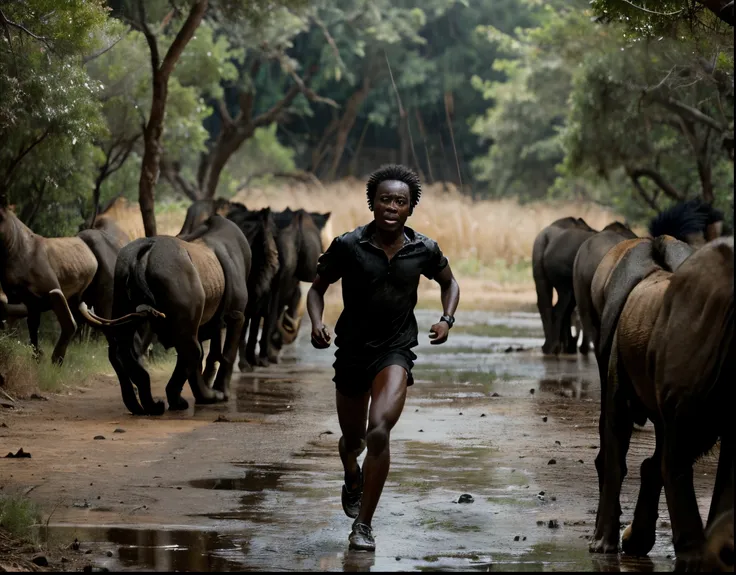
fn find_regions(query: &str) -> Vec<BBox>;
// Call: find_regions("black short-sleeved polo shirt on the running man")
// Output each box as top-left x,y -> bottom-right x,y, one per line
317,222 -> 448,356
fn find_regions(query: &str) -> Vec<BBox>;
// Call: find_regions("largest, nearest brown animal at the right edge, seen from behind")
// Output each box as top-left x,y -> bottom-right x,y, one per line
591,236 -> 736,568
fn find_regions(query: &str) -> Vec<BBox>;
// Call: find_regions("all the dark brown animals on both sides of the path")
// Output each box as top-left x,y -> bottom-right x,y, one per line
0,195 -> 735,570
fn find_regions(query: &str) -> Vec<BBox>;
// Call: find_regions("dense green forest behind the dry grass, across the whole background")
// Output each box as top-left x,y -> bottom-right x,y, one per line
0,0 -> 734,235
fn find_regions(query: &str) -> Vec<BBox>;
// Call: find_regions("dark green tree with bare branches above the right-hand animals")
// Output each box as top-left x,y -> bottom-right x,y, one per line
564,10 -> 734,210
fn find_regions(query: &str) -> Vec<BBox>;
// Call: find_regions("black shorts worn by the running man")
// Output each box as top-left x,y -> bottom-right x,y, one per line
332,349 -> 417,397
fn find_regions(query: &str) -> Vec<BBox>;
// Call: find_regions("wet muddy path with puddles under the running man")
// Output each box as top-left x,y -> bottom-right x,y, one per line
0,311 -> 715,571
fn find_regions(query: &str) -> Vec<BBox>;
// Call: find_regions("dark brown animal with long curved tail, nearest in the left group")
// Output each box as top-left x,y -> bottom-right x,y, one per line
82,215 -> 251,415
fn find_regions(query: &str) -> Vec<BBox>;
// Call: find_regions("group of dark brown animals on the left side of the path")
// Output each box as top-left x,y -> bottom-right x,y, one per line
0,199 -> 330,415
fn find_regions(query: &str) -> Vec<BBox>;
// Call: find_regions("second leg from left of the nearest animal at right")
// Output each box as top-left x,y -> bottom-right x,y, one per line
621,421 -> 662,557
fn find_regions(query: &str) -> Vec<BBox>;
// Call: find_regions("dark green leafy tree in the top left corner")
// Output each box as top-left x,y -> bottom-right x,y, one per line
0,0 -> 105,233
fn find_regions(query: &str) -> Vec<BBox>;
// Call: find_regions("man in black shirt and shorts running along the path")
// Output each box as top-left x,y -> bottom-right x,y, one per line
307,165 -> 460,551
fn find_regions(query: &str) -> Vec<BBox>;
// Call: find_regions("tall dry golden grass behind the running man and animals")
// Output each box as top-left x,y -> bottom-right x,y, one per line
98,179 -> 628,300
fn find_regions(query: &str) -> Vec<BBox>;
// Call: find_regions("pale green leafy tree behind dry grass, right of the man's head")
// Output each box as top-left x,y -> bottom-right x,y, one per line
473,4 -> 601,199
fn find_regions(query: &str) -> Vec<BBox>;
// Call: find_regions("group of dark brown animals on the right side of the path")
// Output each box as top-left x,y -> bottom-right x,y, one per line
533,201 -> 736,571
